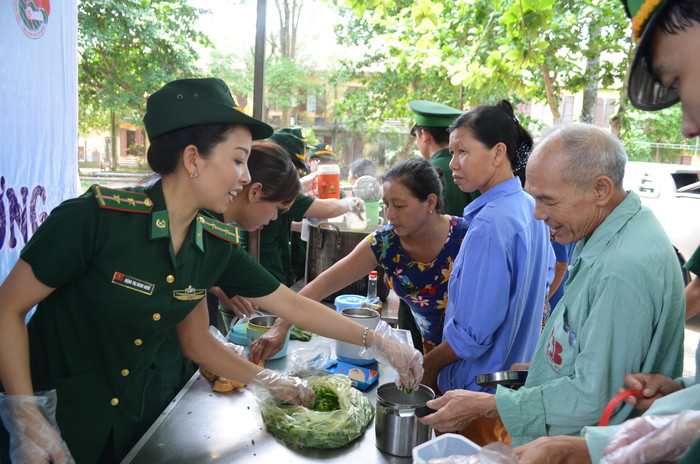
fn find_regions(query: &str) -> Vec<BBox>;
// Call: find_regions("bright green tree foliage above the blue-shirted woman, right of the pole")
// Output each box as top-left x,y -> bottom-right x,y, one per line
336,0 -> 629,129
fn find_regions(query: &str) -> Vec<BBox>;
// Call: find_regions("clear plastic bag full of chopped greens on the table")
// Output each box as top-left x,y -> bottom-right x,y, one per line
257,374 -> 374,449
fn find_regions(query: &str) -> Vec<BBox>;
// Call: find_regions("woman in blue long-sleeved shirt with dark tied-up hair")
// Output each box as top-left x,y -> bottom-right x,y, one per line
423,100 -> 554,444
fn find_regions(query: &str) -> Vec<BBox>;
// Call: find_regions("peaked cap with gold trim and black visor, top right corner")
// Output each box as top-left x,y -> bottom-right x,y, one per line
622,0 -> 680,111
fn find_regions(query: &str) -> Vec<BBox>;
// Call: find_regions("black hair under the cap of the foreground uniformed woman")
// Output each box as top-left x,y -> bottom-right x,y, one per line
146,124 -> 241,176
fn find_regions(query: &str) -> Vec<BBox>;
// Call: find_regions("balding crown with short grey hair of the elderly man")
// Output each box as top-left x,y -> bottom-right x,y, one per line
528,123 -> 627,190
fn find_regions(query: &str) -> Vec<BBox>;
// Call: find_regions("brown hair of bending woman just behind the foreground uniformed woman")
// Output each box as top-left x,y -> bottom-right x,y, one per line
248,140 -> 301,203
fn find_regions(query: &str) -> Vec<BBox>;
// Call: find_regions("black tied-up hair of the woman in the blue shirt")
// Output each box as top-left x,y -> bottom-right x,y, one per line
447,100 -> 532,185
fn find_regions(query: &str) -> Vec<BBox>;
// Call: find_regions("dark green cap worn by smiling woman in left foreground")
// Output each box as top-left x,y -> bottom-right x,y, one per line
143,77 -> 272,140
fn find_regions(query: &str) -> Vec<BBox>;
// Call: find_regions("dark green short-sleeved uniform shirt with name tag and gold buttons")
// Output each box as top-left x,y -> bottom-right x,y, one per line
8,181 -> 279,463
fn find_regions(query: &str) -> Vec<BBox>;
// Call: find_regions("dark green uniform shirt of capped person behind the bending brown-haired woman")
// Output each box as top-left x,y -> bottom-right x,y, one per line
241,194 -> 315,287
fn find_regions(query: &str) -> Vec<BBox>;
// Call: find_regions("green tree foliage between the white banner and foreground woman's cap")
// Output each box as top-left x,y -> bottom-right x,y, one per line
78,0 -> 210,130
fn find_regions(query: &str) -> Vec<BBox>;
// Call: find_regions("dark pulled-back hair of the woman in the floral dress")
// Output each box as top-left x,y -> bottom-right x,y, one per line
382,158 -> 443,212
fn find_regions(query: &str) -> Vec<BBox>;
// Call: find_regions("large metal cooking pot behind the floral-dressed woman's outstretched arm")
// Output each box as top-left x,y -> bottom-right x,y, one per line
305,222 -> 389,302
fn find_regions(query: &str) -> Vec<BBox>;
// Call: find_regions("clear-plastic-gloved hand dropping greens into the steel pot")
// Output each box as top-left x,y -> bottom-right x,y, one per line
360,321 -> 423,391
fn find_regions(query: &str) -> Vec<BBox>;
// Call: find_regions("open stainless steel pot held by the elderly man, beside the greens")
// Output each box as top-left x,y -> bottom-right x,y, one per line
374,382 -> 435,456
